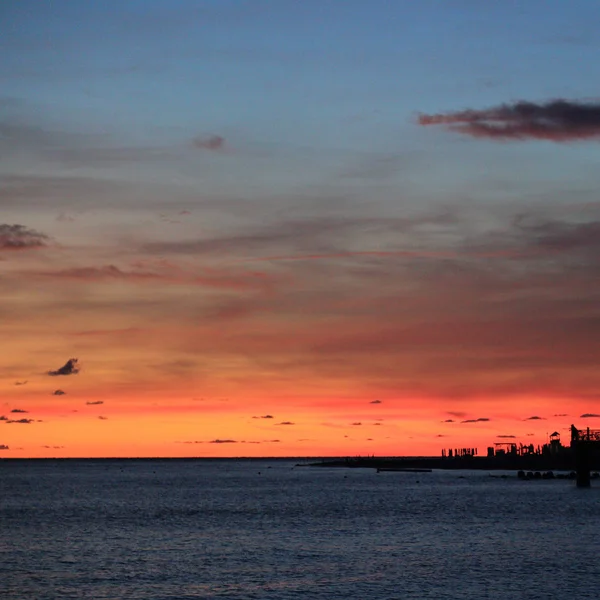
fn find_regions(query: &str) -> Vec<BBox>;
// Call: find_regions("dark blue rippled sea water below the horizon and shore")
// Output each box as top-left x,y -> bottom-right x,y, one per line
0,460 -> 600,600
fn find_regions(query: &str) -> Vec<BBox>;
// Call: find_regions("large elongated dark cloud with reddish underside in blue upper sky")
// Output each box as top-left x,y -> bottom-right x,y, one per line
419,99 -> 600,142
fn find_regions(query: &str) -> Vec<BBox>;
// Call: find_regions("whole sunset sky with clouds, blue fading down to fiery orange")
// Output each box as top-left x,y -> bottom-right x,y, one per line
0,0 -> 600,458
